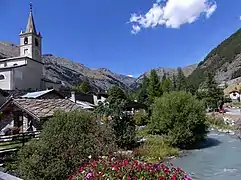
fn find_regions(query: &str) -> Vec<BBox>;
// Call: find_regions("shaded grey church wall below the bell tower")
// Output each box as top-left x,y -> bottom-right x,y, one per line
14,59 -> 43,90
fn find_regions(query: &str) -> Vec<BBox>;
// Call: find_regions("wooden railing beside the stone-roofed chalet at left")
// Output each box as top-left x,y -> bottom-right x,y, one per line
0,131 -> 40,154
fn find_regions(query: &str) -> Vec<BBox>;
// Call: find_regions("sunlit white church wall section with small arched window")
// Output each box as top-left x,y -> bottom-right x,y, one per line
0,69 -> 12,90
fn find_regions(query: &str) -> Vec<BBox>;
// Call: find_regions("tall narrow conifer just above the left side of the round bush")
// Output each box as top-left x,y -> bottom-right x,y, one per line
148,69 -> 162,102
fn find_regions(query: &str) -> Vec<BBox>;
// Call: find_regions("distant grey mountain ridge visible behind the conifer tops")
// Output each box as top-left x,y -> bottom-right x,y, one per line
132,64 -> 197,87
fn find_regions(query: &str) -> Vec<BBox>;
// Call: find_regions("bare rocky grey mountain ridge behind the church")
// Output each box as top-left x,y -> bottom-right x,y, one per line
0,42 -> 135,91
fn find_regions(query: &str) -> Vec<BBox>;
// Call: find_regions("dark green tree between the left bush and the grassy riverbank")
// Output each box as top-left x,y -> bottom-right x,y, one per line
96,86 -> 135,149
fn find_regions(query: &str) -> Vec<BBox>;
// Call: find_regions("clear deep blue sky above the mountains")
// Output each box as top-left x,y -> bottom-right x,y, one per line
0,0 -> 241,76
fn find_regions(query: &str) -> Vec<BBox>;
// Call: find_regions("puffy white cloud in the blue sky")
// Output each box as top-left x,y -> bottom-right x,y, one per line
129,0 -> 217,34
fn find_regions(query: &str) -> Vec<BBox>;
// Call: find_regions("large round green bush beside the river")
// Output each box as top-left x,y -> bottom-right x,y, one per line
149,91 -> 207,148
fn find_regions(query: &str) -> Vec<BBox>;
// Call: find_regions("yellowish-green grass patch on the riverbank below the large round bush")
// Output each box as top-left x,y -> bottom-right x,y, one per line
134,128 -> 181,163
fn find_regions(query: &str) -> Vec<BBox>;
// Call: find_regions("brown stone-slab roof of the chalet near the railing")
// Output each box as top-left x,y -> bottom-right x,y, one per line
1,99 -> 82,119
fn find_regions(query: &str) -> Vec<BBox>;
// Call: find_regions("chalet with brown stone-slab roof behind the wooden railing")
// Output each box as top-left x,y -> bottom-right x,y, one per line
0,98 -> 82,134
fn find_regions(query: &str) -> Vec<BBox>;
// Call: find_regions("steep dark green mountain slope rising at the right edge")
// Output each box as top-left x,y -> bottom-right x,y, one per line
189,28 -> 241,86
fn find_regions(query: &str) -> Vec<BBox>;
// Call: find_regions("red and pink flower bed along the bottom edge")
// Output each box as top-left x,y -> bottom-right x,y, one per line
68,157 -> 191,180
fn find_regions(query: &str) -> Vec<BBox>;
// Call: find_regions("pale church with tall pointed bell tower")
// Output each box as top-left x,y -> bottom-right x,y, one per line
0,5 -> 55,90
